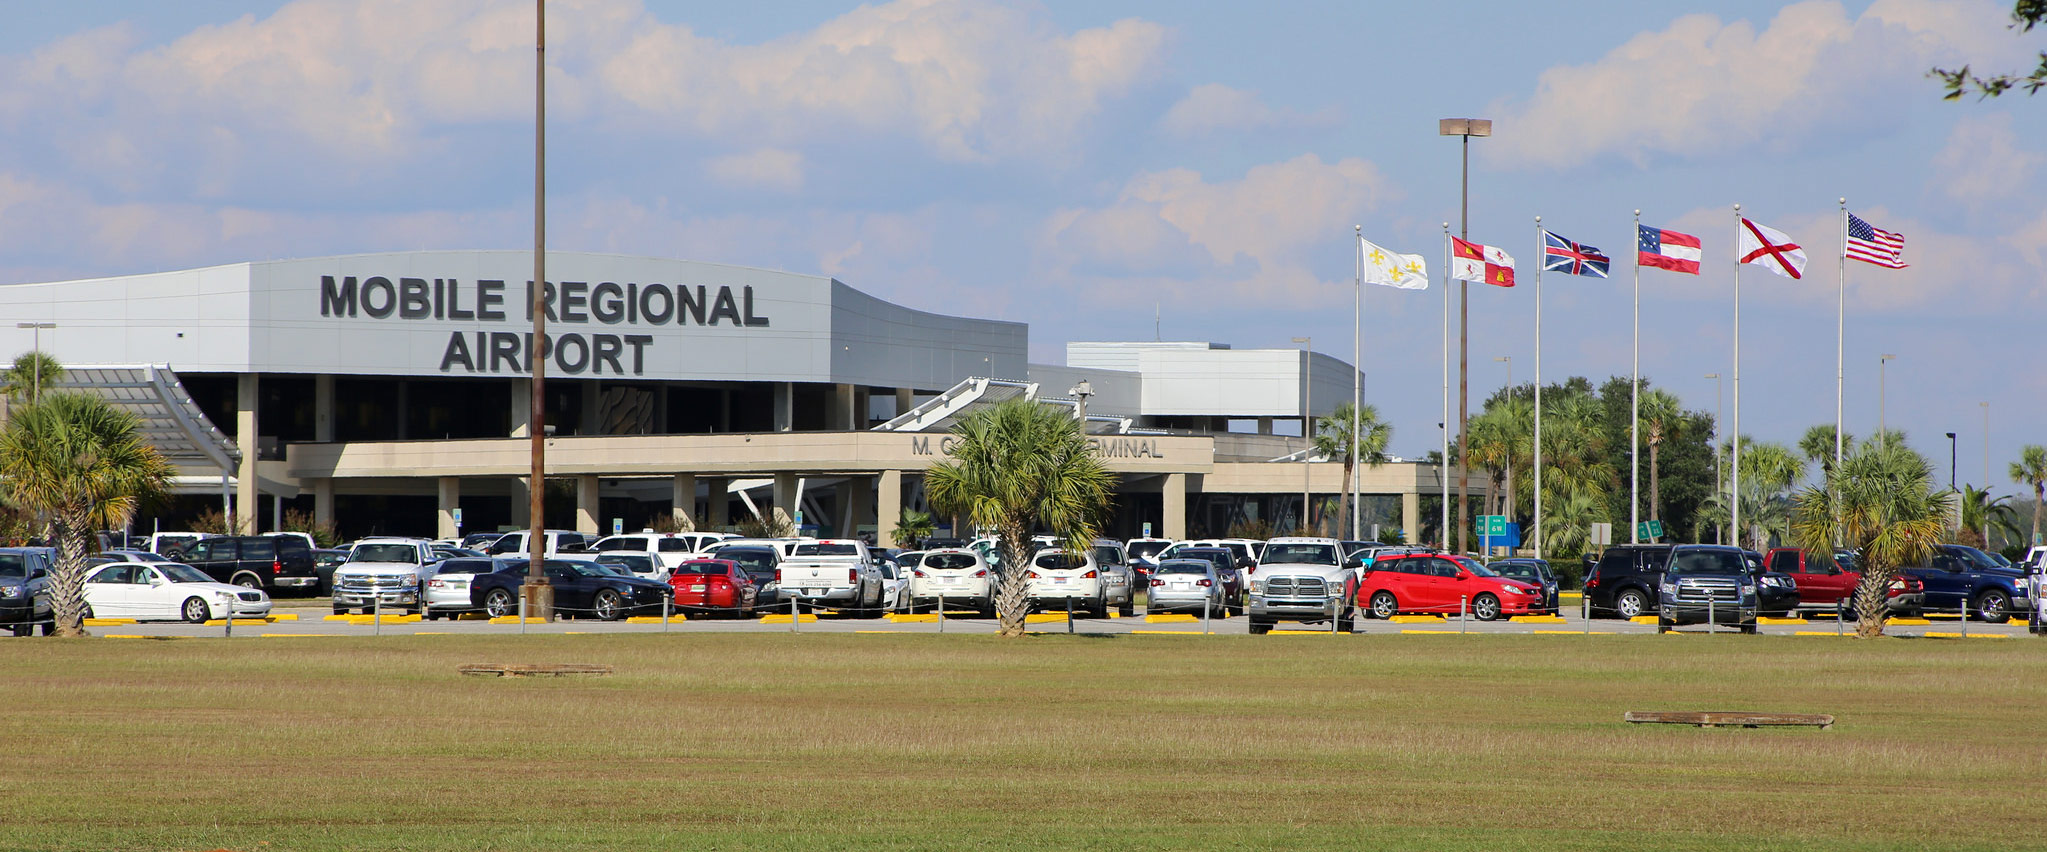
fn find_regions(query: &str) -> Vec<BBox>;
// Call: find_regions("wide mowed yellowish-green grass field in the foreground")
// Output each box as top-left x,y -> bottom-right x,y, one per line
0,635 -> 2047,850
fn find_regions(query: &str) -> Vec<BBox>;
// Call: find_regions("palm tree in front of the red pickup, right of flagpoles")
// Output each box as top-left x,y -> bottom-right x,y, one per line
1791,440 -> 1955,637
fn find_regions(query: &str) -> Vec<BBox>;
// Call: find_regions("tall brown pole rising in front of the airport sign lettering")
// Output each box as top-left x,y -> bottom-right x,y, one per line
520,0 -> 555,621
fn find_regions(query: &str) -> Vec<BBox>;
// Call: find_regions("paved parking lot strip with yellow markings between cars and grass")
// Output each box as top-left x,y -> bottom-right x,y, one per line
68,598 -> 2029,641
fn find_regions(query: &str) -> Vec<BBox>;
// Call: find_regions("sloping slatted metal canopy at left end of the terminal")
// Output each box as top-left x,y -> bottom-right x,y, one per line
49,365 -> 242,475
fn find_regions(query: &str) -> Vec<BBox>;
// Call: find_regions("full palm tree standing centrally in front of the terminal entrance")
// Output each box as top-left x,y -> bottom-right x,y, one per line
923,397 -> 1116,637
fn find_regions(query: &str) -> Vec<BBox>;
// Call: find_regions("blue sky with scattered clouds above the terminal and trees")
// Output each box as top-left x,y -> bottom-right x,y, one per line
0,0 -> 2047,492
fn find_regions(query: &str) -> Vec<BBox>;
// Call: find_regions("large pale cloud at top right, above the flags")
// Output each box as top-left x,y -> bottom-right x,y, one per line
1486,0 -> 2024,166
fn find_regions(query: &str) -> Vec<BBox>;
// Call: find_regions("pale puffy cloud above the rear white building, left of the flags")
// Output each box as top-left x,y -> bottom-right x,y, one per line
1042,154 -> 1398,303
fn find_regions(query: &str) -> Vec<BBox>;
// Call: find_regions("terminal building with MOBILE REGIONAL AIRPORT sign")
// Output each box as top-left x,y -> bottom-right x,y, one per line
0,250 -> 1443,541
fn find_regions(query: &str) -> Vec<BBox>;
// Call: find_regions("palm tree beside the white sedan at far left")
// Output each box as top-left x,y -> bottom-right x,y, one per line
0,393 -> 172,637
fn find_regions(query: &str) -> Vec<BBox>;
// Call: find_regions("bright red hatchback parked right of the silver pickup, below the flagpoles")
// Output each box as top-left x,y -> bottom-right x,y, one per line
1357,553 -> 1541,621
